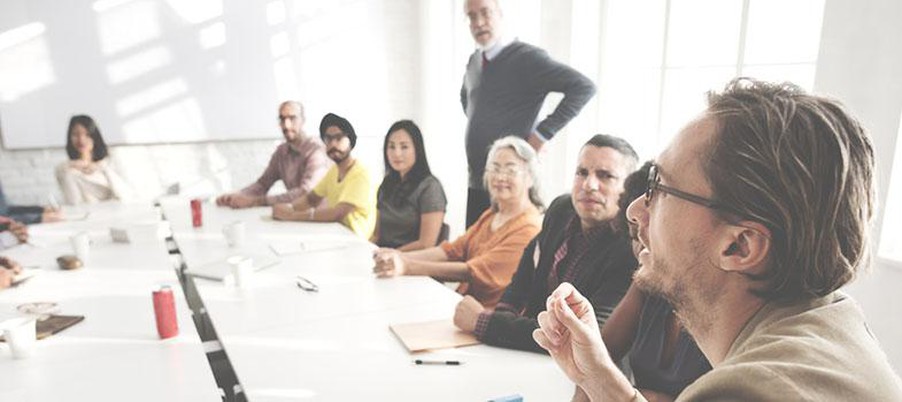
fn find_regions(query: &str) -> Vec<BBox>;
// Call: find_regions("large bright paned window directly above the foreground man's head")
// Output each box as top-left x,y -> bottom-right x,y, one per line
588,0 -> 824,162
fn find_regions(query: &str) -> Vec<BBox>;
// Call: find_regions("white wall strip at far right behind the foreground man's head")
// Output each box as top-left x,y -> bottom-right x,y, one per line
814,0 -> 902,373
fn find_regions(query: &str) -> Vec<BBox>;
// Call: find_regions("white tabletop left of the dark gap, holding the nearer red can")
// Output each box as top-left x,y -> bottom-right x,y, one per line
0,202 -> 221,401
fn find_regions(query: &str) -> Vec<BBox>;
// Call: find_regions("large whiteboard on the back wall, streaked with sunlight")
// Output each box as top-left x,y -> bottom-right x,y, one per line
0,0 -> 406,149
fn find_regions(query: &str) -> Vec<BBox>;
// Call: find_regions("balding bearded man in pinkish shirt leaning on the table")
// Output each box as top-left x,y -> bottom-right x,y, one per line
216,101 -> 331,208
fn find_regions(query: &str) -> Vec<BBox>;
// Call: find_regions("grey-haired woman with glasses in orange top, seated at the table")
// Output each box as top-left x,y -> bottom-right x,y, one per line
373,136 -> 542,307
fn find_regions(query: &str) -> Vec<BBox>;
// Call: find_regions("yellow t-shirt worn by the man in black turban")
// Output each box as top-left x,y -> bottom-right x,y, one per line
313,161 -> 376,239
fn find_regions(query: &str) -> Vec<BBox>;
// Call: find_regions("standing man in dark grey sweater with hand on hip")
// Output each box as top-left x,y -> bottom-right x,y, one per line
460,0 -> 595,227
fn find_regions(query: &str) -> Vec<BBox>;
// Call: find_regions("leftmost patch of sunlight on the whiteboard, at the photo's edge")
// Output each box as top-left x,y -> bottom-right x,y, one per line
0,22 -> 56,102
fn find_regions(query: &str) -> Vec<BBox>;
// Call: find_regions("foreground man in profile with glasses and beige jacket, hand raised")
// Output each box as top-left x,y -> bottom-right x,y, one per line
533,79 -> 902,401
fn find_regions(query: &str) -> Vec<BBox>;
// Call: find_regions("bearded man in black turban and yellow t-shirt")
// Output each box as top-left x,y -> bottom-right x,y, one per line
272,113 -> 376,239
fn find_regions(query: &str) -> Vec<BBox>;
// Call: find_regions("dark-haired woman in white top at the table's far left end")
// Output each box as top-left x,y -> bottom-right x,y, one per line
56,115 -> 131,205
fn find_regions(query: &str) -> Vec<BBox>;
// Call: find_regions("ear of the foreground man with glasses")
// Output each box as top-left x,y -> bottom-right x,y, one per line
718,221 -> 771,275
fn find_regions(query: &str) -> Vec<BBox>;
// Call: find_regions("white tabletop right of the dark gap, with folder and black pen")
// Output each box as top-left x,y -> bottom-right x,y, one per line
161,198 -> 573,402
